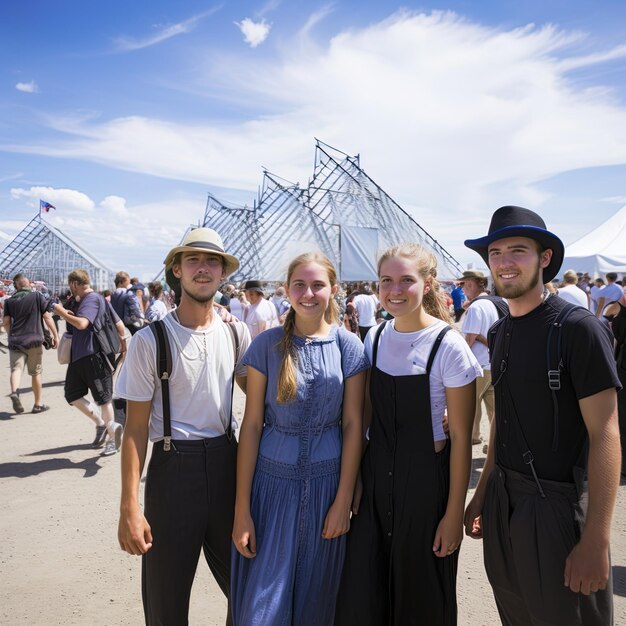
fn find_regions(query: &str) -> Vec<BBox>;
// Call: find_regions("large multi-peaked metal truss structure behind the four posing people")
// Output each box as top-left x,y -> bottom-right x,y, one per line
203,140 -> 462,281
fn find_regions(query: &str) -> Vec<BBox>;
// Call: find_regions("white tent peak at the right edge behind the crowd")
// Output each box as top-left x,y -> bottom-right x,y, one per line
561,206 -> 626,277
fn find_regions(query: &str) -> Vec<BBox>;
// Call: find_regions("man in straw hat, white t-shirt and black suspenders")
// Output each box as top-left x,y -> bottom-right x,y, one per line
116,228 -> 250,624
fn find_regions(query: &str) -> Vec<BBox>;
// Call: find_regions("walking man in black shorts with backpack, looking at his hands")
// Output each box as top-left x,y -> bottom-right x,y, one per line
53,269 -> 126,456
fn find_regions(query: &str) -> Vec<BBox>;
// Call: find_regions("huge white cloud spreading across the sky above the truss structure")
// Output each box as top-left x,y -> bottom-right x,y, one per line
0,7 -> 626,268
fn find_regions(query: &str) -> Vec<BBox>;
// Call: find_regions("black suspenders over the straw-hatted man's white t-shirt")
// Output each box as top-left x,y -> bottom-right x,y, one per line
150,320 -> 239,452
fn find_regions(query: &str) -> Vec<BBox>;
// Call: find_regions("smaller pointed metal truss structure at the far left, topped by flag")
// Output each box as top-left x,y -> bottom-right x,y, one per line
0,214 -> 114,293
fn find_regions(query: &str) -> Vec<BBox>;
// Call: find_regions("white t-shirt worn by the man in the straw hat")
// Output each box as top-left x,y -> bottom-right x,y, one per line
115,313 -> 250,441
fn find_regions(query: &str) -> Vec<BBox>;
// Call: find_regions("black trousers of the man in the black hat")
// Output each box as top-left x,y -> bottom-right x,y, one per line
482,465 -> 613,626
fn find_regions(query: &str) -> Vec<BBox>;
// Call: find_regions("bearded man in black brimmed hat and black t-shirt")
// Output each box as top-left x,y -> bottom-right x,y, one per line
465,206 -> 620,626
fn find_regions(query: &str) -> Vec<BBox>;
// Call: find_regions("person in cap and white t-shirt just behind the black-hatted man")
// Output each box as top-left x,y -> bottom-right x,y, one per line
458,270 -> 499,452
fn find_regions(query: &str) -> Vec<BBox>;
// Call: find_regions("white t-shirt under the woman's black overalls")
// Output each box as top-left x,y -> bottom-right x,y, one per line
365,320 -> 483,441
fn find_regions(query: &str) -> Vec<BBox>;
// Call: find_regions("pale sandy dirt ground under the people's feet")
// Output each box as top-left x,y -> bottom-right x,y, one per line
0,335 -> 626,626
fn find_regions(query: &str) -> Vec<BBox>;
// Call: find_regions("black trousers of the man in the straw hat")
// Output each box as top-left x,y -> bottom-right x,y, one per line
142,435 -> 237,626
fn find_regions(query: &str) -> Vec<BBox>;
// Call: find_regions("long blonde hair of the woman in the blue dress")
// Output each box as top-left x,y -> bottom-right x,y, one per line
276,252 -> 339,404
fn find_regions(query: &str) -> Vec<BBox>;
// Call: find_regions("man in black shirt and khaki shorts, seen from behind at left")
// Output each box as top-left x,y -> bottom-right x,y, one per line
2,274 -> 59,413
